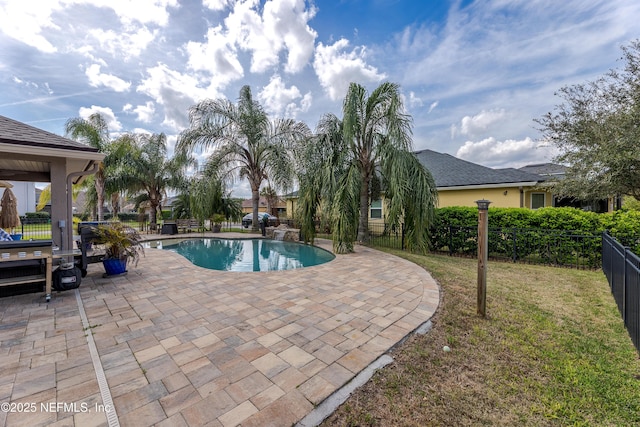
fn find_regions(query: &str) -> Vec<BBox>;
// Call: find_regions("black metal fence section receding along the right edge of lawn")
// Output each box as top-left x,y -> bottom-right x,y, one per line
602,232 -> 640,351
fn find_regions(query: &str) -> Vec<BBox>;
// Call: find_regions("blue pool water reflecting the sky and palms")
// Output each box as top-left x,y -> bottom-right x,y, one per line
158,238 -> 335,271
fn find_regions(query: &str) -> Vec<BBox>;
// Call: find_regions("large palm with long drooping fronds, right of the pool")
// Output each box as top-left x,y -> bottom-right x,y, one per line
299,82 -> 437,253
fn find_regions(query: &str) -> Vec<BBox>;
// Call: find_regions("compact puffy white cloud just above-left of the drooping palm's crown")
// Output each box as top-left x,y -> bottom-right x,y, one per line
313,39 -> 386,101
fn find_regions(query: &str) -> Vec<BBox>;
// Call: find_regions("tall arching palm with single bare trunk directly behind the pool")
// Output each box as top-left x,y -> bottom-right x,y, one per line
178,86 -> 309,231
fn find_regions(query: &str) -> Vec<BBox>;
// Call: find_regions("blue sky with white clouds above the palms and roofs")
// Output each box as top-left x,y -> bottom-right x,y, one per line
0,0 -> 640,197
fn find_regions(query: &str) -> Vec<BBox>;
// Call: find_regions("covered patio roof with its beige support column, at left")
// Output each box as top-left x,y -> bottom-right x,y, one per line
0,116 -> 104,249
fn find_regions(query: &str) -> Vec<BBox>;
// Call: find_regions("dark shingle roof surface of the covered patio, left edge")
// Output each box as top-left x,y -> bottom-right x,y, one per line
0,116 -> 98,152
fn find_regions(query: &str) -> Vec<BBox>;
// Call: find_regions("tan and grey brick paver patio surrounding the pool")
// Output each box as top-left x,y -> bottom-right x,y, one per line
0,234 -> 439,427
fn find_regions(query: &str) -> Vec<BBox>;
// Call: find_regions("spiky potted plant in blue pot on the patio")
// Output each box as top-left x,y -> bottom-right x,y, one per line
95,222 -> 144,276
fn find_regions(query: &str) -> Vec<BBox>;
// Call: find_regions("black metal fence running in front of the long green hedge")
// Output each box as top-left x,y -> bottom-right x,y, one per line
369,223 -> 602,269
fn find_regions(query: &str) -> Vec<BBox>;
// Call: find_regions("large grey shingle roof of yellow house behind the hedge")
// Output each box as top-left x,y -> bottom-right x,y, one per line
415,150 -> 545,188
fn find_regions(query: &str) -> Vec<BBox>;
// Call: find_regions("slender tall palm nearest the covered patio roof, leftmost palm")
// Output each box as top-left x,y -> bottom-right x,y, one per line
64,113 -> 110,221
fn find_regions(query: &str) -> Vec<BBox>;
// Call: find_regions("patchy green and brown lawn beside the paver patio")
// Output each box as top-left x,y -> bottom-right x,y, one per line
323,250 -> 640,426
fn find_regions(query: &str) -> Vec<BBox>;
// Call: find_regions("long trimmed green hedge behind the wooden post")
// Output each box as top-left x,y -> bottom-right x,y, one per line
431,207 -> 640,265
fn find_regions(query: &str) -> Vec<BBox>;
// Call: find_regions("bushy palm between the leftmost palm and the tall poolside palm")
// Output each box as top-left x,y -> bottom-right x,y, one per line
107,133 -> 191,224
